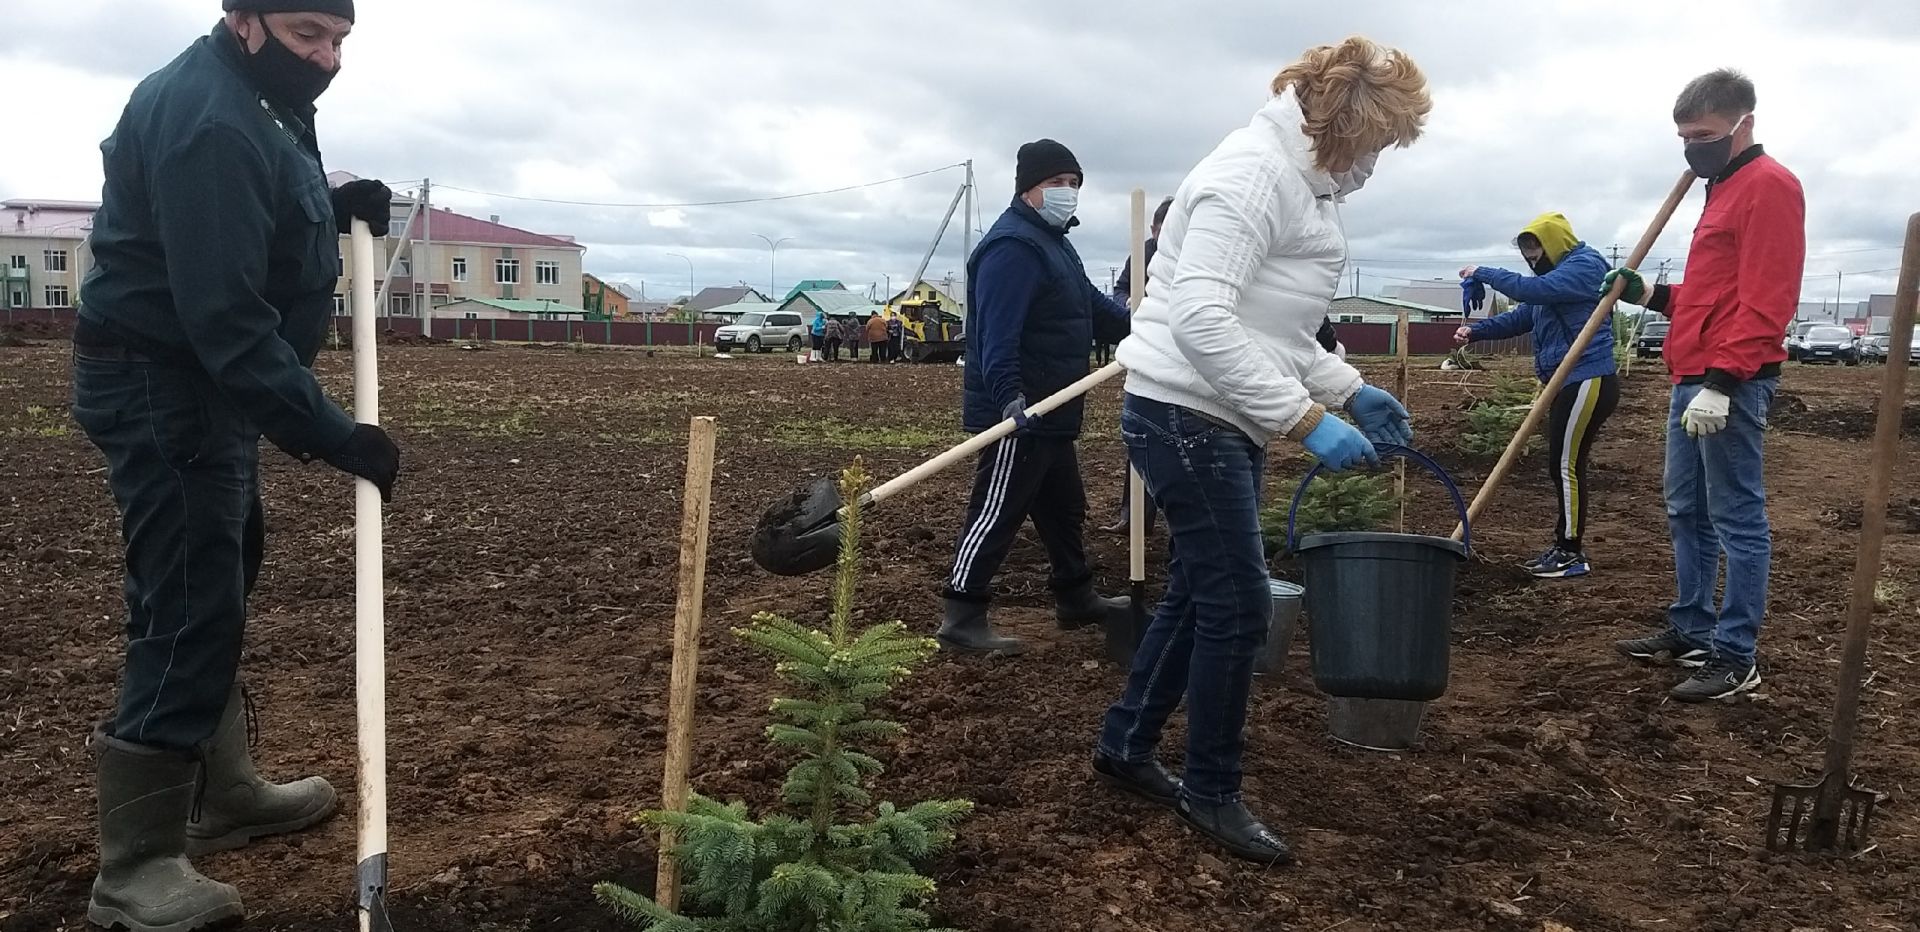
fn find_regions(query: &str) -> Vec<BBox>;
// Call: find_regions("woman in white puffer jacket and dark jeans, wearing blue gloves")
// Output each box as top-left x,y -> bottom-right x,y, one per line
1092,37 -> 1432,863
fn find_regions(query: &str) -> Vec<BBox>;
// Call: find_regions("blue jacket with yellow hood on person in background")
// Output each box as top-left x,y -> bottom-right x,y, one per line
1471,213 -> 1615,382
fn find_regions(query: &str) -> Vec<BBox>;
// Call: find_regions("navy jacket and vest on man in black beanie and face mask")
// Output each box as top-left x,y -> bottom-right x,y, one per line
964,198 -> 1129,436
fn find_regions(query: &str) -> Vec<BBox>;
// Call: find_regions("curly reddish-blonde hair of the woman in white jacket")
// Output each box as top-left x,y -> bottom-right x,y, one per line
1273,37 -> 1434,171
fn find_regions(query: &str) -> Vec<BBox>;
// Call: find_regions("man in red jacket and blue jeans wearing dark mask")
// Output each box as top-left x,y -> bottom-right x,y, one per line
1601,69 -> 1807,701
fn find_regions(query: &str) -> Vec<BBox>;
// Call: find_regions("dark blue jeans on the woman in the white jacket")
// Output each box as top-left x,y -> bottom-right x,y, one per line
1100,394 -> 1273,803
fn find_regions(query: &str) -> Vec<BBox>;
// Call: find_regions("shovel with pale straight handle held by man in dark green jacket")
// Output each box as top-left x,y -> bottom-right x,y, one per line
349,219 -> 394,932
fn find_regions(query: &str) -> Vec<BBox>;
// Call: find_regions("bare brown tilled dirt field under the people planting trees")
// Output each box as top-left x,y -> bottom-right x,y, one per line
0,344 -> 1920,932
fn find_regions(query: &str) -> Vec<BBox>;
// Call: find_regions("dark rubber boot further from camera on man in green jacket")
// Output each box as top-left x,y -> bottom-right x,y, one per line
186,684 -> 336,855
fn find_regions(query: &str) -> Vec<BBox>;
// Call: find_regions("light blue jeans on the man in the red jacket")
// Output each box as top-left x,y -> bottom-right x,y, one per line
1667,379 -> 1780,663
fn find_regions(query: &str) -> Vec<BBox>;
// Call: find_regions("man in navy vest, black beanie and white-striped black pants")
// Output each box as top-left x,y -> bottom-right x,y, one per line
939,138 -> 1129,653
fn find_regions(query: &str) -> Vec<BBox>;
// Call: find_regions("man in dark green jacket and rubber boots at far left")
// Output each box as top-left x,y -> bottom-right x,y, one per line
73,0 -> 399,932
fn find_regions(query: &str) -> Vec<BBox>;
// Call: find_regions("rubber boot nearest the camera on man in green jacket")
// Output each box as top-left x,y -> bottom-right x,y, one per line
86,734 -> 246,932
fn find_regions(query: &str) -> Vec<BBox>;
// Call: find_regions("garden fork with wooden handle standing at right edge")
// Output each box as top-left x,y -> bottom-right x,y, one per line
1766,213 -> 1920,851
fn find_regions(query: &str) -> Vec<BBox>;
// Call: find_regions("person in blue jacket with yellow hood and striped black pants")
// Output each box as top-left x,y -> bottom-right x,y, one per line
1453,213 -> 1620,578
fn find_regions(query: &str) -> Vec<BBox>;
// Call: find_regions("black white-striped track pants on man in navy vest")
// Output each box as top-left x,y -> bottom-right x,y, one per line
943,436 -> 1092,601
